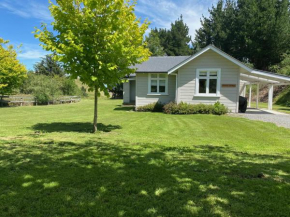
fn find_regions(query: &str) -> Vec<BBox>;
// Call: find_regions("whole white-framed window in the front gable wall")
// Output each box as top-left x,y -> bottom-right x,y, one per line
196,69 -> 221,96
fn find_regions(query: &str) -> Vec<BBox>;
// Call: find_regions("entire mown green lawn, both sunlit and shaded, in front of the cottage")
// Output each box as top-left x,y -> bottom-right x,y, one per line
0,99 -> 290,217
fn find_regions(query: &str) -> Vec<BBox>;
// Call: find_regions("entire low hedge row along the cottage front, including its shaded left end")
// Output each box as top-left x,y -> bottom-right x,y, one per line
137,102 -> 229,115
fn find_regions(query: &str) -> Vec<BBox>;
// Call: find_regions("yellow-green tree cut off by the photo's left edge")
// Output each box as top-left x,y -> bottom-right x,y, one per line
0,38 -> 27,95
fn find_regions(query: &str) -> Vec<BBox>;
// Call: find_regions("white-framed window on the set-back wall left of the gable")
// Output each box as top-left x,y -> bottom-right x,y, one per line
148,74 -> 168,94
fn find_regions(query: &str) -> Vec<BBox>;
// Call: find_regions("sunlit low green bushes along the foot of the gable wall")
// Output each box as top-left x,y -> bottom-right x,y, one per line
163,102 -> 228,115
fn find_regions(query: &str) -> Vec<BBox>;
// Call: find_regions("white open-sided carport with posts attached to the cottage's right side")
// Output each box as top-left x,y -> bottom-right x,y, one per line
240,68 -> 290,110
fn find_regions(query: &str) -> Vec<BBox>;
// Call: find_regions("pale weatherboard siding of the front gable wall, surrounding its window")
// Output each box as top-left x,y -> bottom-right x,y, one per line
176,50 -> 240,112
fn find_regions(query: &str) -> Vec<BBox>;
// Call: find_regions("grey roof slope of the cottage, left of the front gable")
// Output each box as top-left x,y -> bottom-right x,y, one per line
132,56 -> 190,73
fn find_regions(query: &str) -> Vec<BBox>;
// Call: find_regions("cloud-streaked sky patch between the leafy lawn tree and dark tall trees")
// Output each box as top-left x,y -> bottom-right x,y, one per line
135,0 -> 217,39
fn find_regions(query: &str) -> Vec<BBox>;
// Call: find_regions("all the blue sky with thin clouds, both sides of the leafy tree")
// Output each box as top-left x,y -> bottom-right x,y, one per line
0,0 -> 217,69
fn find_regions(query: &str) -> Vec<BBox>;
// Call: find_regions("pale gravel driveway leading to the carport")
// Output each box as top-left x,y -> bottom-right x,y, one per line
230,109 -> 290,129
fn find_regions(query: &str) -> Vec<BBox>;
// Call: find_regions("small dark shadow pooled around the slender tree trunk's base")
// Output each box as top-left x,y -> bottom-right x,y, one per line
32,122 -> 121,133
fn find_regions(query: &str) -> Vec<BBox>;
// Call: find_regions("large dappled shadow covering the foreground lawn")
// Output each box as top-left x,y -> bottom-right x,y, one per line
0,141 -> 290,217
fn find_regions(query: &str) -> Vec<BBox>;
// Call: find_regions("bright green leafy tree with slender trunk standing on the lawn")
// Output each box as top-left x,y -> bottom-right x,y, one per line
35,0 -> 150,132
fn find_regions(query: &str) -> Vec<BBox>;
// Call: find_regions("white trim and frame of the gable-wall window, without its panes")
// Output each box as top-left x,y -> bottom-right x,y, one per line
195,68 -> 221,97
